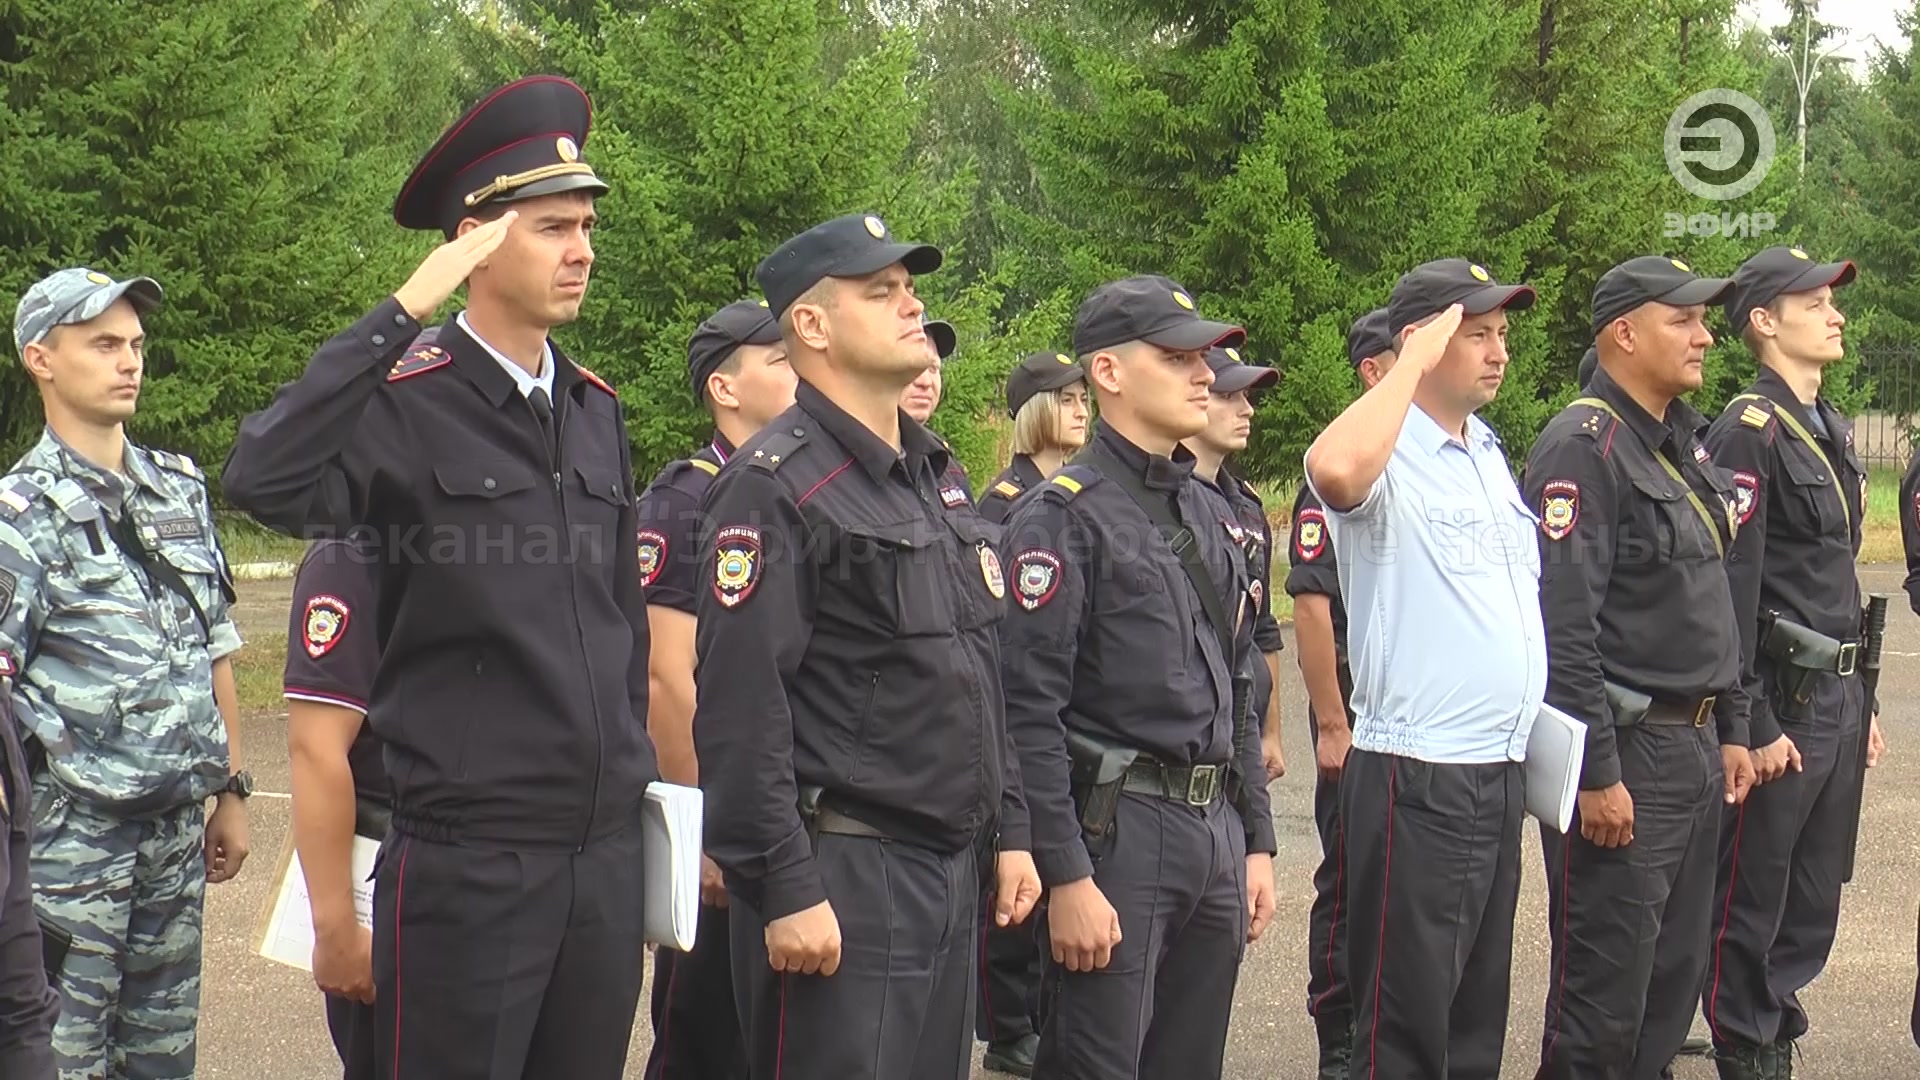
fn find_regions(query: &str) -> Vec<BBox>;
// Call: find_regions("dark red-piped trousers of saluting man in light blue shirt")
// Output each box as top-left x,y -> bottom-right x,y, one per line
1340,748 -> 1526,1080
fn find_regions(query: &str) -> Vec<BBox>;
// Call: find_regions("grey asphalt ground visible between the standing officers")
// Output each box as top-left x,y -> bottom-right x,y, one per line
200,565 -> 1920,1080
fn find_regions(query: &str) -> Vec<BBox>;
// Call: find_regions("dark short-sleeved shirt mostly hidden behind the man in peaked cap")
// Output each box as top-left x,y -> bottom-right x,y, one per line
280,540 -> 392,814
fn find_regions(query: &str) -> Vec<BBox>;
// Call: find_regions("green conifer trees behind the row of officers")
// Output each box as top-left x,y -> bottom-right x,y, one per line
0,0 -> 1920,484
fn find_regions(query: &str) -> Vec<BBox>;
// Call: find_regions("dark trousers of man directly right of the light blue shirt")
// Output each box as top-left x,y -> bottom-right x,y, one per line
1536,705 -> 1726,1080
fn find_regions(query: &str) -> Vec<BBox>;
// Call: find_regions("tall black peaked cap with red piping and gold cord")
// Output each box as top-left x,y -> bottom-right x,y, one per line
394,75 -> 607,233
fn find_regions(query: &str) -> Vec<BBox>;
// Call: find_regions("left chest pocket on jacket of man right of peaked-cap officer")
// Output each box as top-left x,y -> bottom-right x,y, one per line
844,521 -> 960,638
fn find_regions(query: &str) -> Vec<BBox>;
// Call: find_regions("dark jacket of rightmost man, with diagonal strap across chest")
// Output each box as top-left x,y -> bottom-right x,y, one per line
1707,367 -> 1866,746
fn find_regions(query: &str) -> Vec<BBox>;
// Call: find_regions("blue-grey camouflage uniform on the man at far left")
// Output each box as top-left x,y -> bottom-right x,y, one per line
0,430 -> 240,1080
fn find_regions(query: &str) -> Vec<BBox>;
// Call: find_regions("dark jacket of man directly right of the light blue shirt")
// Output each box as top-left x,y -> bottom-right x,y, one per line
1526,359 -> 1747,790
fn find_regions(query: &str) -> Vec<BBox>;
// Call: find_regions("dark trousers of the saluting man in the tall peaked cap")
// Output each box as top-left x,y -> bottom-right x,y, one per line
372,819 -> 645,1080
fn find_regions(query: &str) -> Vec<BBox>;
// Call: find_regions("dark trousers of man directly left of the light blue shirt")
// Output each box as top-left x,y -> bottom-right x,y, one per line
1033,792 -> 1246,1080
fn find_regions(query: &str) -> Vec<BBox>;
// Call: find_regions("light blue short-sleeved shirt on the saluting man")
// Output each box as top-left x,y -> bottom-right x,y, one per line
1315,405 -> 1548,765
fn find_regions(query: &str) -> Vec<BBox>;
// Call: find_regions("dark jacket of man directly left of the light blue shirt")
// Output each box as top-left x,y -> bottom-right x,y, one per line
1002,423 -> 1275,888
